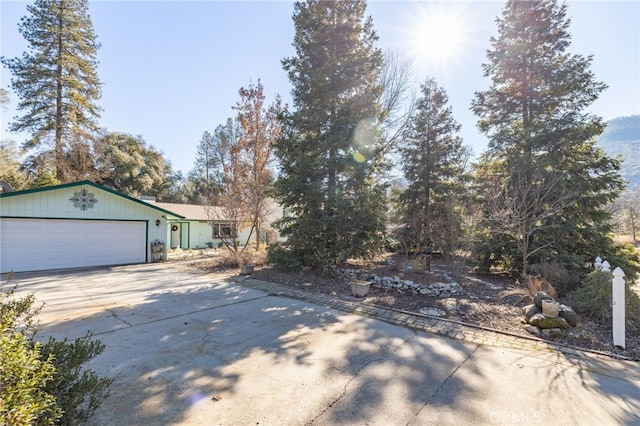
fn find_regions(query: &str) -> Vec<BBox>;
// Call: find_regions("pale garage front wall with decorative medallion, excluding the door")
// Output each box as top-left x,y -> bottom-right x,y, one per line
0,185 -> 178,262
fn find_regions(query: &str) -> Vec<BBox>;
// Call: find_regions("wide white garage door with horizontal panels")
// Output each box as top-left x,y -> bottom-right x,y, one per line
0,219 -> 146,272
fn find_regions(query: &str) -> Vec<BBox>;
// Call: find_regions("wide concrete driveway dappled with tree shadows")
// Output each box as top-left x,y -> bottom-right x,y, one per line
8,264 -> 640,425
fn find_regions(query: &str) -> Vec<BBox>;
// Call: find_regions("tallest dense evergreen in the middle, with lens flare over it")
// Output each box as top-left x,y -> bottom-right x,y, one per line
275,0 -> 385,267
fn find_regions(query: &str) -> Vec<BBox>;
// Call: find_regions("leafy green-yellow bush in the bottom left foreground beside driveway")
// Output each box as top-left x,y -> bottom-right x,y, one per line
0,277 -> 112,425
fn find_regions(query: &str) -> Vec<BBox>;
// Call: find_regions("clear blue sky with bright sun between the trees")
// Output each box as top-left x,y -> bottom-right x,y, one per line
0,0 -> 640,174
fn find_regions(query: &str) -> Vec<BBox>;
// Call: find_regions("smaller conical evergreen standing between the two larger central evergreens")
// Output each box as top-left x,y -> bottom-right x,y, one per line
400,79 -> 469,252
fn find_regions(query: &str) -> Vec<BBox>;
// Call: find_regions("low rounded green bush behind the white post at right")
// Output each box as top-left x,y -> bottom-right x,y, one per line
569,270 -> 640,329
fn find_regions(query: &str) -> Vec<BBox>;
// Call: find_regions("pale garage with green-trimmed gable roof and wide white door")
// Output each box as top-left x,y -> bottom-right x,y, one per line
0,181 -> 183,273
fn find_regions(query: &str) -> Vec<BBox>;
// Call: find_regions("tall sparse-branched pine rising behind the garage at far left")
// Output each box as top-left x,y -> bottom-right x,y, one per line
2,0 -> 101,182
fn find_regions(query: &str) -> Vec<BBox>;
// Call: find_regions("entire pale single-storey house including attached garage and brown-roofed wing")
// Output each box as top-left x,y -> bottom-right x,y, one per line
0,181 -> 282,273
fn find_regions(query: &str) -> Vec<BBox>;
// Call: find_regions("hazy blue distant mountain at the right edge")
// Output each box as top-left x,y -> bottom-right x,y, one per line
598,115 -> 640,190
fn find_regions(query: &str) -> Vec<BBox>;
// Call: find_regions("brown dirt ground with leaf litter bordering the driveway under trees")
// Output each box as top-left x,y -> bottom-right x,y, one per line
189,256 -> 640,361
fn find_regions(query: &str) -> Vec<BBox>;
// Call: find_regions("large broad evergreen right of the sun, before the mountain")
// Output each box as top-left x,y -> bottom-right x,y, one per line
472,0 -> 622,280
